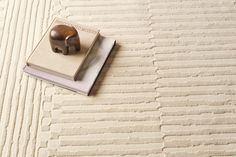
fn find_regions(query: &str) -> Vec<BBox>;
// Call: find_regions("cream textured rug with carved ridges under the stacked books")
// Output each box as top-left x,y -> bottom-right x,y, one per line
0,0 -> 236,157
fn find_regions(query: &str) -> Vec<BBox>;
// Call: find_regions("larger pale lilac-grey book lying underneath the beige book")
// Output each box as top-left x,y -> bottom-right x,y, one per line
23,36 -> 116,95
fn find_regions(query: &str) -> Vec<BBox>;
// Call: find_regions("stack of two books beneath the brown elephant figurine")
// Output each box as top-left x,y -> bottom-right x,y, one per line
24,18 -> 115,95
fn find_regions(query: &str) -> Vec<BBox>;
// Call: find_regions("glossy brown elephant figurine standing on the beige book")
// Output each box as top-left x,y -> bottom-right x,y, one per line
49,25 -> 80,55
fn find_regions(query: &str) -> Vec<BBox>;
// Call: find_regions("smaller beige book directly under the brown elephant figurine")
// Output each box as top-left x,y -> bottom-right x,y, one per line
26,18 -> 99,80
